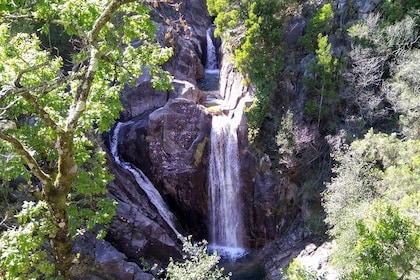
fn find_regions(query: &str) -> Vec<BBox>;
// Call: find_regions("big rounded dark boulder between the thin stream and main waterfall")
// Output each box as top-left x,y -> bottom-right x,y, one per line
148,98 -> 211,238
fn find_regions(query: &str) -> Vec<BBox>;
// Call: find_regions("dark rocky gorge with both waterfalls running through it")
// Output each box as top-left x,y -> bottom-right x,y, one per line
98,0 -> 398,279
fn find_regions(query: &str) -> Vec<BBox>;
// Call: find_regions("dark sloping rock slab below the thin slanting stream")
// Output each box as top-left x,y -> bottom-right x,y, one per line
107,151 -> 182,263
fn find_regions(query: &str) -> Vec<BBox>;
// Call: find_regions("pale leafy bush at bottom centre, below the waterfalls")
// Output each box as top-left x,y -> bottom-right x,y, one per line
166,236 -> 229,280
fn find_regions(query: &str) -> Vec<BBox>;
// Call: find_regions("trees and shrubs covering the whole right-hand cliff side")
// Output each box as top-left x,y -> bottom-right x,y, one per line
208,0 -> 420,279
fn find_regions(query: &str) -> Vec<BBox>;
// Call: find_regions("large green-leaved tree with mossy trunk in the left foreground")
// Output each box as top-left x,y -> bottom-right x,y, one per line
0,0 -> 171,279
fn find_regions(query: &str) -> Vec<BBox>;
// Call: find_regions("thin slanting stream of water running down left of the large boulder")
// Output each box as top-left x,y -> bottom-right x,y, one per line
110,121 -> 182,238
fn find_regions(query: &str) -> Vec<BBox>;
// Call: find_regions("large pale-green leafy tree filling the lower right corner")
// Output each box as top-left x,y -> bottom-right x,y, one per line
323,130 -> 420,279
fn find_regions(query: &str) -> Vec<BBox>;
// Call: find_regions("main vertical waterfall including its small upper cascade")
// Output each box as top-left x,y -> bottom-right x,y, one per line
206,26 -> 246,259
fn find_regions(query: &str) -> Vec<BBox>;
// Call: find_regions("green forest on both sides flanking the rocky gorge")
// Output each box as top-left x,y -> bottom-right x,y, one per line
0,0 -> 420,279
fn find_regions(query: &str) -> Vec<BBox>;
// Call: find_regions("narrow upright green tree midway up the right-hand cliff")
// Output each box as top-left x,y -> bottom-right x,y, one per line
304,34 -> 339,129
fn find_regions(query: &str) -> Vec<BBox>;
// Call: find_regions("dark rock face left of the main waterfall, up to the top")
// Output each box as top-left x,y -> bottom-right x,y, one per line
107,0 -> 211,270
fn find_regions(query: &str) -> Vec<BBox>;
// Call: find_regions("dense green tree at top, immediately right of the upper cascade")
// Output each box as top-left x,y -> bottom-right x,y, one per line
207,0 -> 298,137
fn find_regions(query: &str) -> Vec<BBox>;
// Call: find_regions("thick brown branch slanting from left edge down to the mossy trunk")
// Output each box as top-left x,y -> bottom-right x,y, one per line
0,131 -> 52,186
